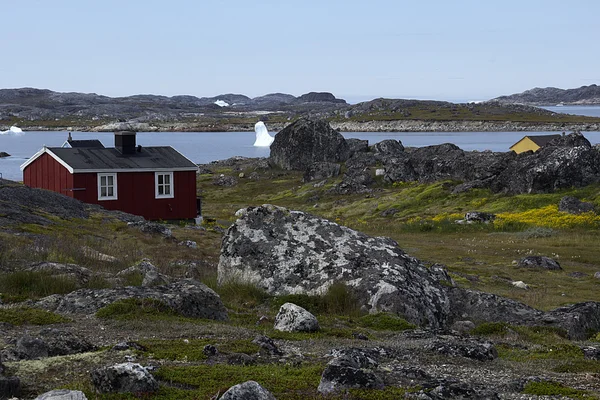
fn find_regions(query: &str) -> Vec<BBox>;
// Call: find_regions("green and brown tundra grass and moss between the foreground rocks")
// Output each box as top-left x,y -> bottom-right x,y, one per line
0,167 -> 600,399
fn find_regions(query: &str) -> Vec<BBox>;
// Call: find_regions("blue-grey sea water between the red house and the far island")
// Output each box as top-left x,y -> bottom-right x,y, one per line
0,131 -> 600,181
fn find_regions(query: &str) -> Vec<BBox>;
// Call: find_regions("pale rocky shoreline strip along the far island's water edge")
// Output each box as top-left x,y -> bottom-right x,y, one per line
7,120 -> 600,132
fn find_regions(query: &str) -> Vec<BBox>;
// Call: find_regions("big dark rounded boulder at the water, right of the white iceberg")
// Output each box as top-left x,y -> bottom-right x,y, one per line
270,119 -> 350,171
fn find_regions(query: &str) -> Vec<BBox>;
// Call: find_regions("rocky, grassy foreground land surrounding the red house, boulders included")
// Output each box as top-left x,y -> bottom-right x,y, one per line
0,119 -> 600,400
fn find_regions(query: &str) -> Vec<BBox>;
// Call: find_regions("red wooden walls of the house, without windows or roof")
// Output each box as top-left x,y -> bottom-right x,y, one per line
23,154 -> 197,220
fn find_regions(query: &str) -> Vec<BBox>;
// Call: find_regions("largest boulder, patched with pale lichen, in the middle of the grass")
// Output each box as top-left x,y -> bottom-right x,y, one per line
218,205 -> 450,328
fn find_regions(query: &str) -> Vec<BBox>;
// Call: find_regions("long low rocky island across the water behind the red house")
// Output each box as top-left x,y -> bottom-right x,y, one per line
0,88 -> 600,132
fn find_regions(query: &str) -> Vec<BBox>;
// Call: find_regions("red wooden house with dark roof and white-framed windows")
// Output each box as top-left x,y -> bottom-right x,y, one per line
21,131 -> 198,220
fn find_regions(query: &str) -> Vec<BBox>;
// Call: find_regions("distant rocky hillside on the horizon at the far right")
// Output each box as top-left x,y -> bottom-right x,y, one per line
490,85 -> 600,106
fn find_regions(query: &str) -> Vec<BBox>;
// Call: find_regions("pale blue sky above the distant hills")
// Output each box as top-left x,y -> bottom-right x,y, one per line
0,0 -> 600,102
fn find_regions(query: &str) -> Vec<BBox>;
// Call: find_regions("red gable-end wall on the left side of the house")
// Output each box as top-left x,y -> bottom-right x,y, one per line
23,153 -> 75,197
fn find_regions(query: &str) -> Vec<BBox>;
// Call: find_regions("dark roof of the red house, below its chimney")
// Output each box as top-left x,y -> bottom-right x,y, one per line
48,146 -> 198,172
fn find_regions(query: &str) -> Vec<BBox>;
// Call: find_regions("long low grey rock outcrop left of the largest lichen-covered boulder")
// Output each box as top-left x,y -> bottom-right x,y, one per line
36,279 -> 227,320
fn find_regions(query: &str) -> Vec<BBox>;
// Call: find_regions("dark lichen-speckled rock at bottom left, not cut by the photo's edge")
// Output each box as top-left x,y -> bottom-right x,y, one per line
90,363 -> 158,394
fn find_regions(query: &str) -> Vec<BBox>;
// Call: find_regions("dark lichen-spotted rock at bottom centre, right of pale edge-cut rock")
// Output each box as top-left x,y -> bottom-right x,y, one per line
317,349 -> 384,395
